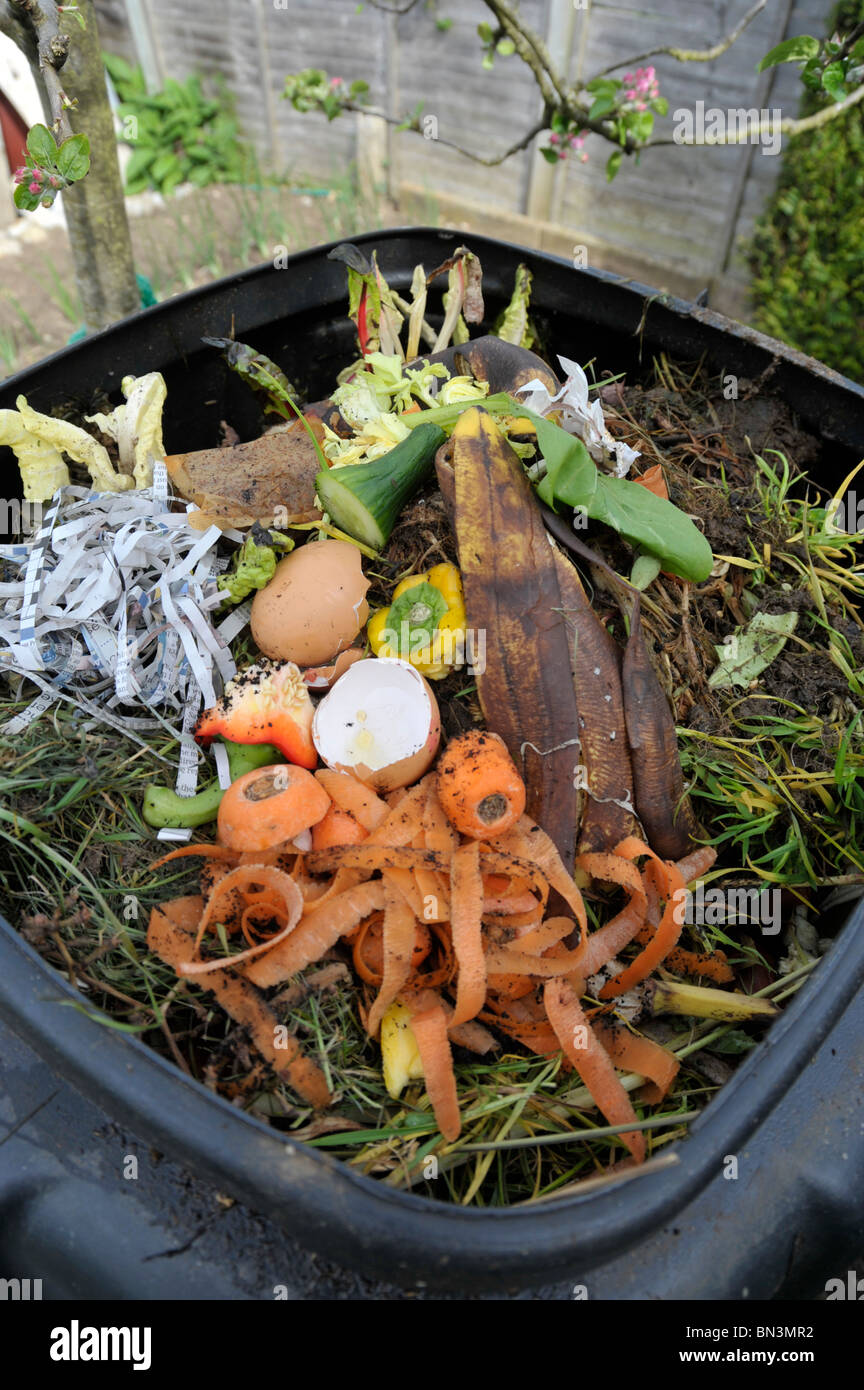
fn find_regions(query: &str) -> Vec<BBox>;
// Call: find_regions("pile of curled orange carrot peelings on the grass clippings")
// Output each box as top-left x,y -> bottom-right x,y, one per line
148,770 -> 728,1161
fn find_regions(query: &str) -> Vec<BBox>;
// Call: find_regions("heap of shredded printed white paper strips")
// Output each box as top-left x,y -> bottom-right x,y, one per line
0,463 -> 249,795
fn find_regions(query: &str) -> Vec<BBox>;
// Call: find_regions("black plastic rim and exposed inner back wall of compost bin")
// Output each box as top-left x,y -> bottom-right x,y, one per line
0,228 -> 864,1290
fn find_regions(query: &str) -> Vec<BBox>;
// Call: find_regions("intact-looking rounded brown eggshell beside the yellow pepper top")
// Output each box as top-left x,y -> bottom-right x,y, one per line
251,541 -> 369,666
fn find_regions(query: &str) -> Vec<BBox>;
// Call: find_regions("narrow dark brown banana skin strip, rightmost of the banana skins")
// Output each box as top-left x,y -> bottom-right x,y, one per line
621,599 -> 699,859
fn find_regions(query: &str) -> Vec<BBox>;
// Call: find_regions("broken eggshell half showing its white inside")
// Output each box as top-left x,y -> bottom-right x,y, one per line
313,657 -> 440,794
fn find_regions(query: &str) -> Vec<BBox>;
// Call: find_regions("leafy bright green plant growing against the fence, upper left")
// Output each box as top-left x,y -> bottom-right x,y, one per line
106,54 -> 254,193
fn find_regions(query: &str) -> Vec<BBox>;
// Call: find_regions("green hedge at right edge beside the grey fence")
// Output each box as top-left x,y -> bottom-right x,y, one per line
750,0 -> 864,381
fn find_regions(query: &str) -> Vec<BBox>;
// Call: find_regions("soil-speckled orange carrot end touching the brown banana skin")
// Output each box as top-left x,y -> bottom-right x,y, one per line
436,728 -> 525,840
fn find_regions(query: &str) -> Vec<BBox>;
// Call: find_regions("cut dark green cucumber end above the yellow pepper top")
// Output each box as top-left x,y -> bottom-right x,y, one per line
315,424 -> 447,550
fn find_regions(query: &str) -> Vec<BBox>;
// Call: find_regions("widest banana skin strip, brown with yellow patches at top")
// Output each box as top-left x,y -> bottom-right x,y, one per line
442,407 -> 581,870
